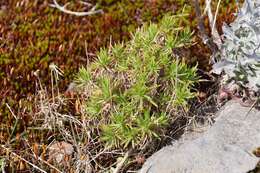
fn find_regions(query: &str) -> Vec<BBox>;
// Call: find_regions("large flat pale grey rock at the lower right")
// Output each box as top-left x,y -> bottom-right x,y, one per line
140,102 -> 260,173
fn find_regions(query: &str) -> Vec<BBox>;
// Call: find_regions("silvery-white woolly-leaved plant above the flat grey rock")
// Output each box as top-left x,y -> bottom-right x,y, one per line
213,0 -> 260,93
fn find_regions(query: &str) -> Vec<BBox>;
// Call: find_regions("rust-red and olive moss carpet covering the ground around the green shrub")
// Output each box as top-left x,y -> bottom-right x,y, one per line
0,0 -> 240,172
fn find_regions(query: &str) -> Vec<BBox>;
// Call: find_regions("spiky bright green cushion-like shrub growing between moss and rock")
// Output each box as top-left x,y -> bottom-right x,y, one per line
75,16 -> 198,147
